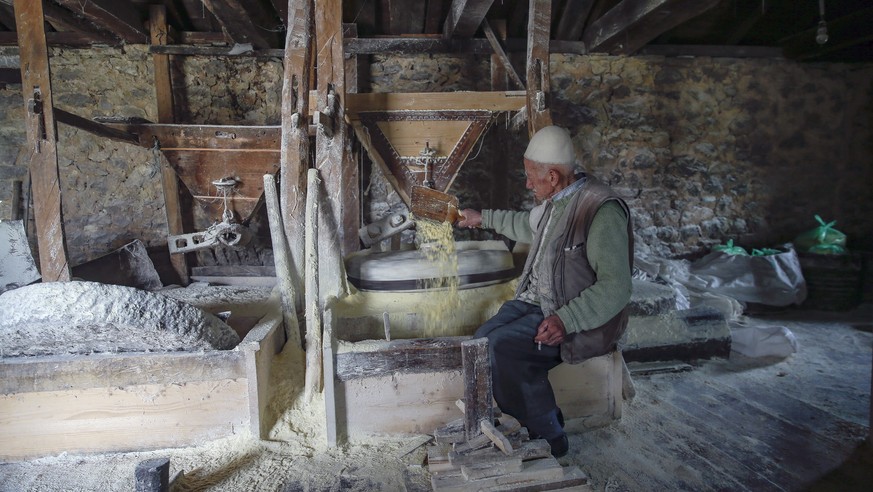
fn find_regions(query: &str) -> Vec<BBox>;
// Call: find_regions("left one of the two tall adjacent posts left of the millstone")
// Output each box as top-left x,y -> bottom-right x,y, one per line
279,0 -> 312,311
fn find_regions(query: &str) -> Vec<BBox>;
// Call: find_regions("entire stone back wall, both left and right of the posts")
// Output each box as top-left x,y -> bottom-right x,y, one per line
0,46 -> 873,264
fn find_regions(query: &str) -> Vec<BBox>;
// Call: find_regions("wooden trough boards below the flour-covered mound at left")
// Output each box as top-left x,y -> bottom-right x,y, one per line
0,308 -> 285,460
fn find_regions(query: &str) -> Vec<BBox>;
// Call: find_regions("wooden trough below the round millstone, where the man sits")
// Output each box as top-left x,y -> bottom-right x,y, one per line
325,328 -> 623,441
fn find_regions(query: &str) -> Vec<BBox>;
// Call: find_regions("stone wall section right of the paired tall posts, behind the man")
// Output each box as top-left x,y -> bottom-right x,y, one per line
371,55 -> 873,257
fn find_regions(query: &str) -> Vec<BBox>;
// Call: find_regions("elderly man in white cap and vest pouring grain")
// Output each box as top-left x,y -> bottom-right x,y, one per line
457,126 -> 633,457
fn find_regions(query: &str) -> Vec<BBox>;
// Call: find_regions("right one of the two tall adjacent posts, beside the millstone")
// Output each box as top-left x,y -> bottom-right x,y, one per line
314,0 -> 360,260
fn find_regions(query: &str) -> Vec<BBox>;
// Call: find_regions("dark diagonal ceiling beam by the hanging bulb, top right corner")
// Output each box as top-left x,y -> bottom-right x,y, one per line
779,7 -> 873,60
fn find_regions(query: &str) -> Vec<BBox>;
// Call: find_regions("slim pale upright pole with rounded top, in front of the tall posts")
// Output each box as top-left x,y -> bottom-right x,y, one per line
303,169 -> 322,401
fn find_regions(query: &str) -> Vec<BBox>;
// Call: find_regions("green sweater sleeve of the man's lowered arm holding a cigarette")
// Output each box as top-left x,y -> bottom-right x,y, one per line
557,202 -> 632,332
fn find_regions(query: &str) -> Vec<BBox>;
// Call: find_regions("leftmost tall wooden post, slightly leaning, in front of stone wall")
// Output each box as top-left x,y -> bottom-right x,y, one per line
13,0 -> 70,282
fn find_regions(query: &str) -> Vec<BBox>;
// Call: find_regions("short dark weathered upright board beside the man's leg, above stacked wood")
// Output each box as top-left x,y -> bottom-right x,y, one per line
461,338 -> 494,440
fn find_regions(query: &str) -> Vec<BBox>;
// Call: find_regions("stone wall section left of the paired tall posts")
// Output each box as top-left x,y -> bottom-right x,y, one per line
0,46 -> 282,265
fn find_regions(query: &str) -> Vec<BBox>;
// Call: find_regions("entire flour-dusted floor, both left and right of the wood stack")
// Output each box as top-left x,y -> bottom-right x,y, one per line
0,304 -> 873,491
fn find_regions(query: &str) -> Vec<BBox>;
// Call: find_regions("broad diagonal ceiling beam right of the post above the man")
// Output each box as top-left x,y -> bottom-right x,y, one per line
582,0 -> 719,55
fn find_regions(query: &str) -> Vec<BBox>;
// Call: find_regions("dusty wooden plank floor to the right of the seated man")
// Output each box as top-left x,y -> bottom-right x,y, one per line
561,306 -> 873,491
